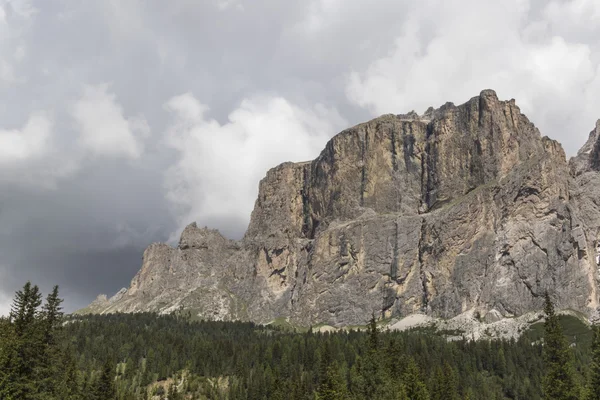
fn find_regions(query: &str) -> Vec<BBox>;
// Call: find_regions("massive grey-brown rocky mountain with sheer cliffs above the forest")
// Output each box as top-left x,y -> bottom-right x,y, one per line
82,90 -> 600,326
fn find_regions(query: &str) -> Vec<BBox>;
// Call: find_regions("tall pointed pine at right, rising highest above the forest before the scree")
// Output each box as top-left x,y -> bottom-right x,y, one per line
542,293 -> 580,400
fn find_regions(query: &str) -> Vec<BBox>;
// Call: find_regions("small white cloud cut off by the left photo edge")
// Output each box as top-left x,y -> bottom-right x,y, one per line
0,112 -> 52,166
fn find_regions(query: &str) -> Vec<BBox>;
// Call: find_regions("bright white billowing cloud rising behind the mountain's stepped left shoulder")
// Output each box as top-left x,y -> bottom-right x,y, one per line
165,93 -> 346,239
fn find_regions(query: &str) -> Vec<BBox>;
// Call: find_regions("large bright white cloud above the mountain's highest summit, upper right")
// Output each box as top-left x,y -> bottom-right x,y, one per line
346,0 -> 600,154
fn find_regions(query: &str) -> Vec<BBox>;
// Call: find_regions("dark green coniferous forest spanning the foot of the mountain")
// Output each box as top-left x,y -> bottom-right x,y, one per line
0,283 -> 600,400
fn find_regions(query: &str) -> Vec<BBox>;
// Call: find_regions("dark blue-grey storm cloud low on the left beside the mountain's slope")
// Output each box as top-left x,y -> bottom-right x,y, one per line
0,158 -> 176,309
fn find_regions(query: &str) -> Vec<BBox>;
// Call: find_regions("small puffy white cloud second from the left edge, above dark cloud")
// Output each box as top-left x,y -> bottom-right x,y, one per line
71,84 -> 150,159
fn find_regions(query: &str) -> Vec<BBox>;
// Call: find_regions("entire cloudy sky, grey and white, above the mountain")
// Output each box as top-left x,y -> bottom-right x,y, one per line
0,0 -> 600,314
